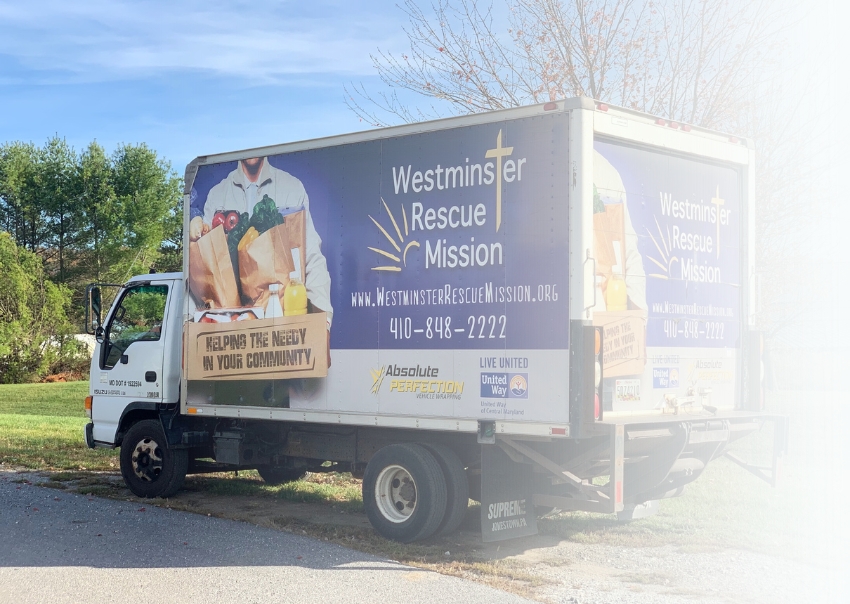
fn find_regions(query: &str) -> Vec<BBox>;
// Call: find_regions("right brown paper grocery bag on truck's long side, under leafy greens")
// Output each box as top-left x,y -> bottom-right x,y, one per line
239,224 -> 295,302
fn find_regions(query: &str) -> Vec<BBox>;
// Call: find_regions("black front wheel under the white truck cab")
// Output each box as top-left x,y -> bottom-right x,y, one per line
119,419 -> 189,498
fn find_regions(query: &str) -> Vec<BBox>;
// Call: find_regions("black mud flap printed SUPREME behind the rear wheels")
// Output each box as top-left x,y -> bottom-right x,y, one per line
481,445 -> 537,543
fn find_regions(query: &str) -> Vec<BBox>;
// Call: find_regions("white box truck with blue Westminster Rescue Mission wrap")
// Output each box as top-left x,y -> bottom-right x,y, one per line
85,98 -> 784,542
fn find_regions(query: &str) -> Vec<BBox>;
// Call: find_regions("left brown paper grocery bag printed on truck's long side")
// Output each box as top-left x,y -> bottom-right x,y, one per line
189,226 -> 240,308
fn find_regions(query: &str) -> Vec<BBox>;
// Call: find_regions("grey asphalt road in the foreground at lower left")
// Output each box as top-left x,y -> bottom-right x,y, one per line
0,474 -> 527,604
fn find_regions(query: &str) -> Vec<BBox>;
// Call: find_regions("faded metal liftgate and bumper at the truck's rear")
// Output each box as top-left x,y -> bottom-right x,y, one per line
496,412 -> 787,518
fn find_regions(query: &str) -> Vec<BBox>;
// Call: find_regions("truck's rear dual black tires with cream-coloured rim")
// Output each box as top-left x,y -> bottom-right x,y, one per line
363,443 -> 446,543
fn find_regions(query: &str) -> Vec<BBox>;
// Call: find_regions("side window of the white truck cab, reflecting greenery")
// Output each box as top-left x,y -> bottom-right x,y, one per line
103,285 -> 168,369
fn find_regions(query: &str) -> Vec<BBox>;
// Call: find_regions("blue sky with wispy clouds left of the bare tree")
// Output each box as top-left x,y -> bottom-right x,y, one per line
0,0 -> 414,174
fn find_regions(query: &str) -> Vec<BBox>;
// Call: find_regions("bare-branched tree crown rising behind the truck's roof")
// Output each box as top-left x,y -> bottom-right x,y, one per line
347,0 -> 786,128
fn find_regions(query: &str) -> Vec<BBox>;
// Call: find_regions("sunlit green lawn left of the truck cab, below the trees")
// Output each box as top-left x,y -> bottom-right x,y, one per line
0,382 -> 118,470
